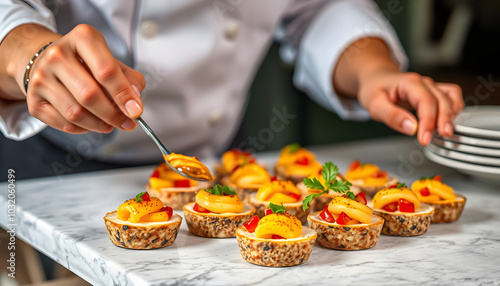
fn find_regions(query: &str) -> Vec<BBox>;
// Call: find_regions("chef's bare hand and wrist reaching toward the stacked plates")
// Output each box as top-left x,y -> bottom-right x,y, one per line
332,38 -> 464,145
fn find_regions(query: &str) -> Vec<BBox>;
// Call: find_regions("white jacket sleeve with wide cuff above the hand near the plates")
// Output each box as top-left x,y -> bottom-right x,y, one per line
276,0 -> 408,120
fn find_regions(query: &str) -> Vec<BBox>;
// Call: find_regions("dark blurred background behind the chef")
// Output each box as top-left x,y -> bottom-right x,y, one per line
234,0 -> 500,151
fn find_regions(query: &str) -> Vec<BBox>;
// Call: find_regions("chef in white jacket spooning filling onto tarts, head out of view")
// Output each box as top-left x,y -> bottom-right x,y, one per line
0,0 -> 464,163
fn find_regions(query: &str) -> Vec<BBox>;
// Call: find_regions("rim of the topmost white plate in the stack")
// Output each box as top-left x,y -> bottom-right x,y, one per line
454,105 -> 500,139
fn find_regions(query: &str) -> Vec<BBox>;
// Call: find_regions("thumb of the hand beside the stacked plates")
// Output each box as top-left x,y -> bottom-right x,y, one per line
368,92 -> 418,136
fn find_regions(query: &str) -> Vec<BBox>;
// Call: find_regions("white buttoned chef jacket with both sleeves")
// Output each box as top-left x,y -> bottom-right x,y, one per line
0,0 -> 407,163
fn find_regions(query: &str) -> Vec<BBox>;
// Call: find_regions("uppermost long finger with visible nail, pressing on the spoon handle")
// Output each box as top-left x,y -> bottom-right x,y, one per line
68,24 -> 143,118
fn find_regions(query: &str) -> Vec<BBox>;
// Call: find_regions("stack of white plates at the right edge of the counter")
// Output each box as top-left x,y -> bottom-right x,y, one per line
425,106 -> 500,184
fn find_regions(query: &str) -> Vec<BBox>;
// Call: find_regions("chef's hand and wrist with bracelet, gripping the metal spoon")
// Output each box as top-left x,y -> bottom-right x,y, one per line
0,24 -> 146,134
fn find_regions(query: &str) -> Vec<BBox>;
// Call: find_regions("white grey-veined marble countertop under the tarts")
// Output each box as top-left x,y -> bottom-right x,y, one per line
0,138 -> 500,285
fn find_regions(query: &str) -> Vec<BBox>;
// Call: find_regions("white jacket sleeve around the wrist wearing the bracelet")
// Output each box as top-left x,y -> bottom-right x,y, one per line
0,0 -> 56,140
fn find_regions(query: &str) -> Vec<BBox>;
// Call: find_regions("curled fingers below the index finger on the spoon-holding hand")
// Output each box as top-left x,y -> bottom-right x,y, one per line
34,40 -> 135,132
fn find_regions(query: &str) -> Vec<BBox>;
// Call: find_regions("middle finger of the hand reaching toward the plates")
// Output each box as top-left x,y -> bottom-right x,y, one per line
423,77 -> 453,137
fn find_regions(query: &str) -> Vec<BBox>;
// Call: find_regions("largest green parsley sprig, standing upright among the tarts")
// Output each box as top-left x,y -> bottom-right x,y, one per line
302,162 -> 356,211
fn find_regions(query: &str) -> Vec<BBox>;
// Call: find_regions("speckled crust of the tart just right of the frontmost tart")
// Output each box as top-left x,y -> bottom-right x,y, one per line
307,211 -> 384,250
